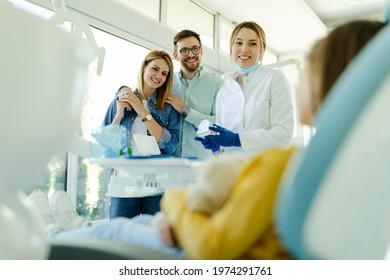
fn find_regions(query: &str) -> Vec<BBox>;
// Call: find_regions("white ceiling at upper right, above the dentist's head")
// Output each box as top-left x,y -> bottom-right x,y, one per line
194,0 -> 387,54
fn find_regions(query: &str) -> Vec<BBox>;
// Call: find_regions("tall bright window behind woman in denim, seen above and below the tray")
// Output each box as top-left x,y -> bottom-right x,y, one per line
76,28 -> 149,219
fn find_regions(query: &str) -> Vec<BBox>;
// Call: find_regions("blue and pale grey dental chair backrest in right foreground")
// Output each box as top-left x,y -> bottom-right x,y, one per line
275,2 -> 390,259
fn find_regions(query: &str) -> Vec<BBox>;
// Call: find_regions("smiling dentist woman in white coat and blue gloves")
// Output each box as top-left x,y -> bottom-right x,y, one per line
195,21 -> 294,157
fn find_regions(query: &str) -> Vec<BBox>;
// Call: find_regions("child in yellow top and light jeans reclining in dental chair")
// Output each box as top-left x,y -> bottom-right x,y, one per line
26,21 -> 384,259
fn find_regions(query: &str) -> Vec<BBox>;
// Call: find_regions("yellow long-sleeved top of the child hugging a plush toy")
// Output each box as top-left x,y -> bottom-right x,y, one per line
161,149 -> 294,259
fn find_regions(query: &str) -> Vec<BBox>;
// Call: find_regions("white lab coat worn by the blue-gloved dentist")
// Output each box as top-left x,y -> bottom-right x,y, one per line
216,65 -> 294,157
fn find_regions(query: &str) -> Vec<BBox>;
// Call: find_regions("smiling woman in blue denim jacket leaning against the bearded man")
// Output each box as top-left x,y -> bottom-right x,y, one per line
103,50 -> 180,218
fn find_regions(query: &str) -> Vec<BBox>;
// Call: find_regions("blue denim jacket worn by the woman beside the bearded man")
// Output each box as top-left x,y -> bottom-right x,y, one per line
103,90 -> 180,154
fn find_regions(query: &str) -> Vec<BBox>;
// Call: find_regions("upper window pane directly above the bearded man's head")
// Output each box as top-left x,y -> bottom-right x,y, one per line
167,0 -> 214,49
